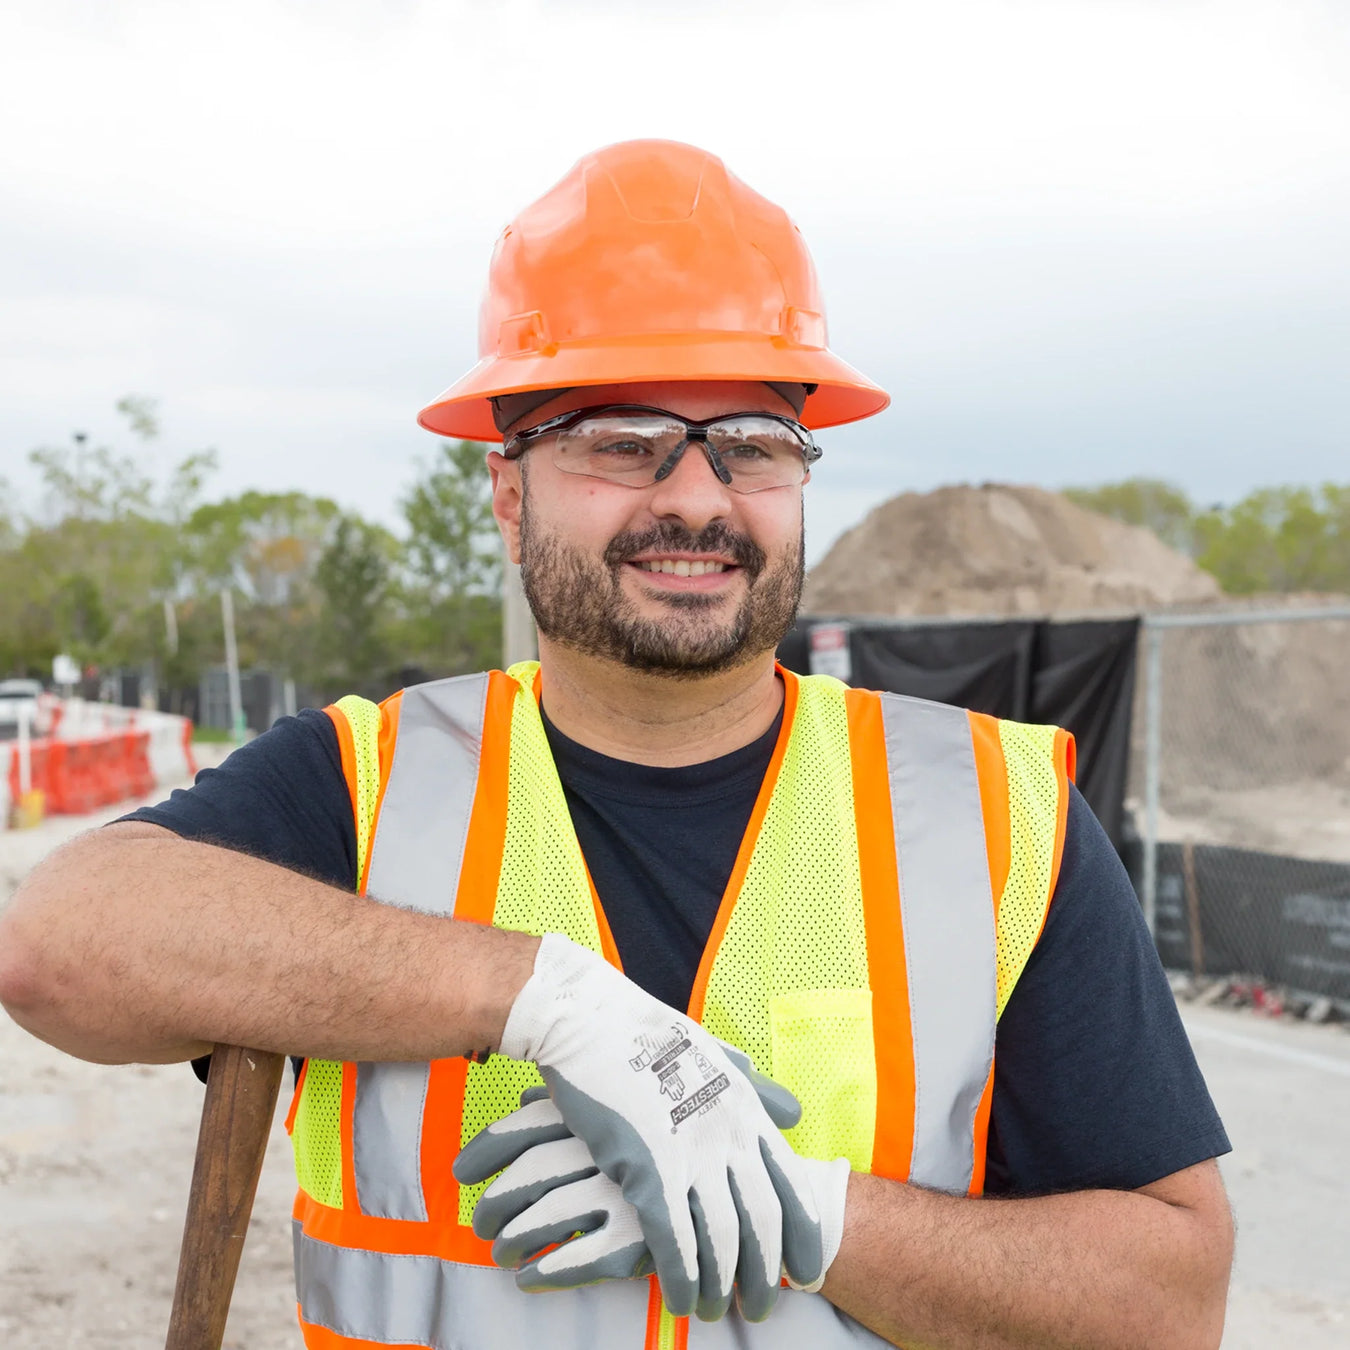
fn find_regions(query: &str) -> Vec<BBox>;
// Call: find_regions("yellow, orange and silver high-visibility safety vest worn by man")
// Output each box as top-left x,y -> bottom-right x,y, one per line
288,663 -> 1073,1350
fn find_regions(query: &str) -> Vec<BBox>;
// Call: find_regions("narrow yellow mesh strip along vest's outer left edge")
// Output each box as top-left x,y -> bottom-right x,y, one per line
290,694 -> 381,1210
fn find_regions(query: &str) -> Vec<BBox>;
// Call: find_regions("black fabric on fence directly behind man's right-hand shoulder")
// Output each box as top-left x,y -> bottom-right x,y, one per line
778,617 -> 1139,848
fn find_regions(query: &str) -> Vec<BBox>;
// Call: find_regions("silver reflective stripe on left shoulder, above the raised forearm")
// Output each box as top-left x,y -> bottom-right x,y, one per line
366,675 -> 487,914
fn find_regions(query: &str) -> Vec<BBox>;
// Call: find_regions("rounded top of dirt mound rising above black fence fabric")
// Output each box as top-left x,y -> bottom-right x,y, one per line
802,483 -> 1222,618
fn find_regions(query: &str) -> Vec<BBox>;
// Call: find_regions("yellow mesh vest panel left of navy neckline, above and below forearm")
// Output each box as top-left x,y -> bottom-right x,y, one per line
459,662 -> 601,1224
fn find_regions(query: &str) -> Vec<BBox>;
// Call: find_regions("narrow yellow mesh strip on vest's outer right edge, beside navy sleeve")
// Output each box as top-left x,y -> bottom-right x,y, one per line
996,721 -> 1060,1017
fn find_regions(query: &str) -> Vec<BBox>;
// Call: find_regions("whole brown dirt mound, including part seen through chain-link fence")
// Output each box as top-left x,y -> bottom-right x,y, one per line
802,483 -> 1350,860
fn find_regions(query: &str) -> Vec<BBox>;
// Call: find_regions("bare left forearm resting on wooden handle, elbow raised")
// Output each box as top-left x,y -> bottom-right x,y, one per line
0,822 -> 537,1064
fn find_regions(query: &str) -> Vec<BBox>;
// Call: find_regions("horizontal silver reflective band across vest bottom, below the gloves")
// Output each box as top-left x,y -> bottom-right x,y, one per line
292,1222 -> 887,1350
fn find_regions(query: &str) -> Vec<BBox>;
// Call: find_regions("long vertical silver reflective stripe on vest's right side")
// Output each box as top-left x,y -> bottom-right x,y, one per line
880,694 -> 996,1193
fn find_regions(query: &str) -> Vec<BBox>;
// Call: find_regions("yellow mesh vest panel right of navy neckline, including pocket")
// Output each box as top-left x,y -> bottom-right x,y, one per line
702,675 -> 876,1172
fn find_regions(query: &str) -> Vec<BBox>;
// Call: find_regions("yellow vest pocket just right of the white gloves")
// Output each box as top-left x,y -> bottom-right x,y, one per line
768,990 -> 876,1172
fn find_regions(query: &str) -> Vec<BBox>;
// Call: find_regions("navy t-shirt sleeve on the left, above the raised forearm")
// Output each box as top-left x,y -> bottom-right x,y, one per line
122,709 -> 356,890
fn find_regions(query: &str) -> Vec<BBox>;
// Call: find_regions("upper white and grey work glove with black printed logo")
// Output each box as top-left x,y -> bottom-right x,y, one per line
455,933 -> 824,1319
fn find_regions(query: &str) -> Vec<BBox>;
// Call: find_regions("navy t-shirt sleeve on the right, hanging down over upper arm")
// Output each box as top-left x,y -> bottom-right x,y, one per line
986,787 -> 1230,1195
